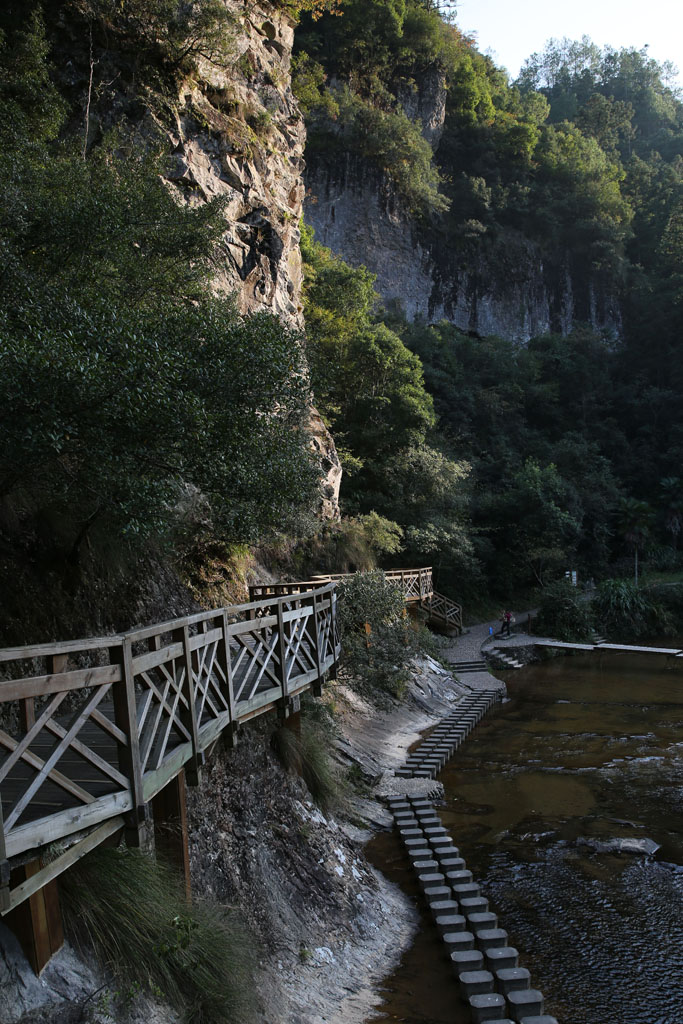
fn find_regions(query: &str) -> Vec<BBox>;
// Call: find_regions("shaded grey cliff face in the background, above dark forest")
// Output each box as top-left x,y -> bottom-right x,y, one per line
305,74 -> 622,342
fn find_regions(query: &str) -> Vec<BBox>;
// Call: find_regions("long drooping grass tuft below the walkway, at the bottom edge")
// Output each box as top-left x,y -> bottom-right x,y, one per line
60,848 -> 254,1024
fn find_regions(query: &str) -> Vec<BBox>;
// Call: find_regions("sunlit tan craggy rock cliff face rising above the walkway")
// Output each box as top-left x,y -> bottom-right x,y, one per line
160,0 -> 342,519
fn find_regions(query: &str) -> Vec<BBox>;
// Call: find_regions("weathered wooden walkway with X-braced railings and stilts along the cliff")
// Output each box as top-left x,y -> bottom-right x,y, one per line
0,568 -> 462,971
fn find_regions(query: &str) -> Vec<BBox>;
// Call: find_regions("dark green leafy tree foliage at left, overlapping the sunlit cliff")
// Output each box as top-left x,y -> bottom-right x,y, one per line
0,16 -> 315,577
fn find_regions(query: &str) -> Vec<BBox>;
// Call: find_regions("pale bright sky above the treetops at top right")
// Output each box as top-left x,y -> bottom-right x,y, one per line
456,0 -> 683,86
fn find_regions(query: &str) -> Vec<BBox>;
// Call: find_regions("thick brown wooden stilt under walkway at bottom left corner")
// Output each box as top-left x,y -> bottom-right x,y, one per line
4,860 -> 65,974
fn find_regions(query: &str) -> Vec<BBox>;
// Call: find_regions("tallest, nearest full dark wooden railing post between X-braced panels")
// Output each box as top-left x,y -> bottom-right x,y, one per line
110,637 -> 154,851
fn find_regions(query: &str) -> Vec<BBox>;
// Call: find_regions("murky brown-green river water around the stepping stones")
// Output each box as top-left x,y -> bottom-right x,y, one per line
371,653 -> 683,1024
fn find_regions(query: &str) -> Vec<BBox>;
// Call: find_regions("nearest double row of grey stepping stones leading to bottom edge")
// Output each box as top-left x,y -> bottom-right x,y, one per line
388,798 -> 558,1024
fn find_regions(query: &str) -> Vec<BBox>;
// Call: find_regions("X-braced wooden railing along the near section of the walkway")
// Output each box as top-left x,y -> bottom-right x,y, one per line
0,583 -> 340,911
